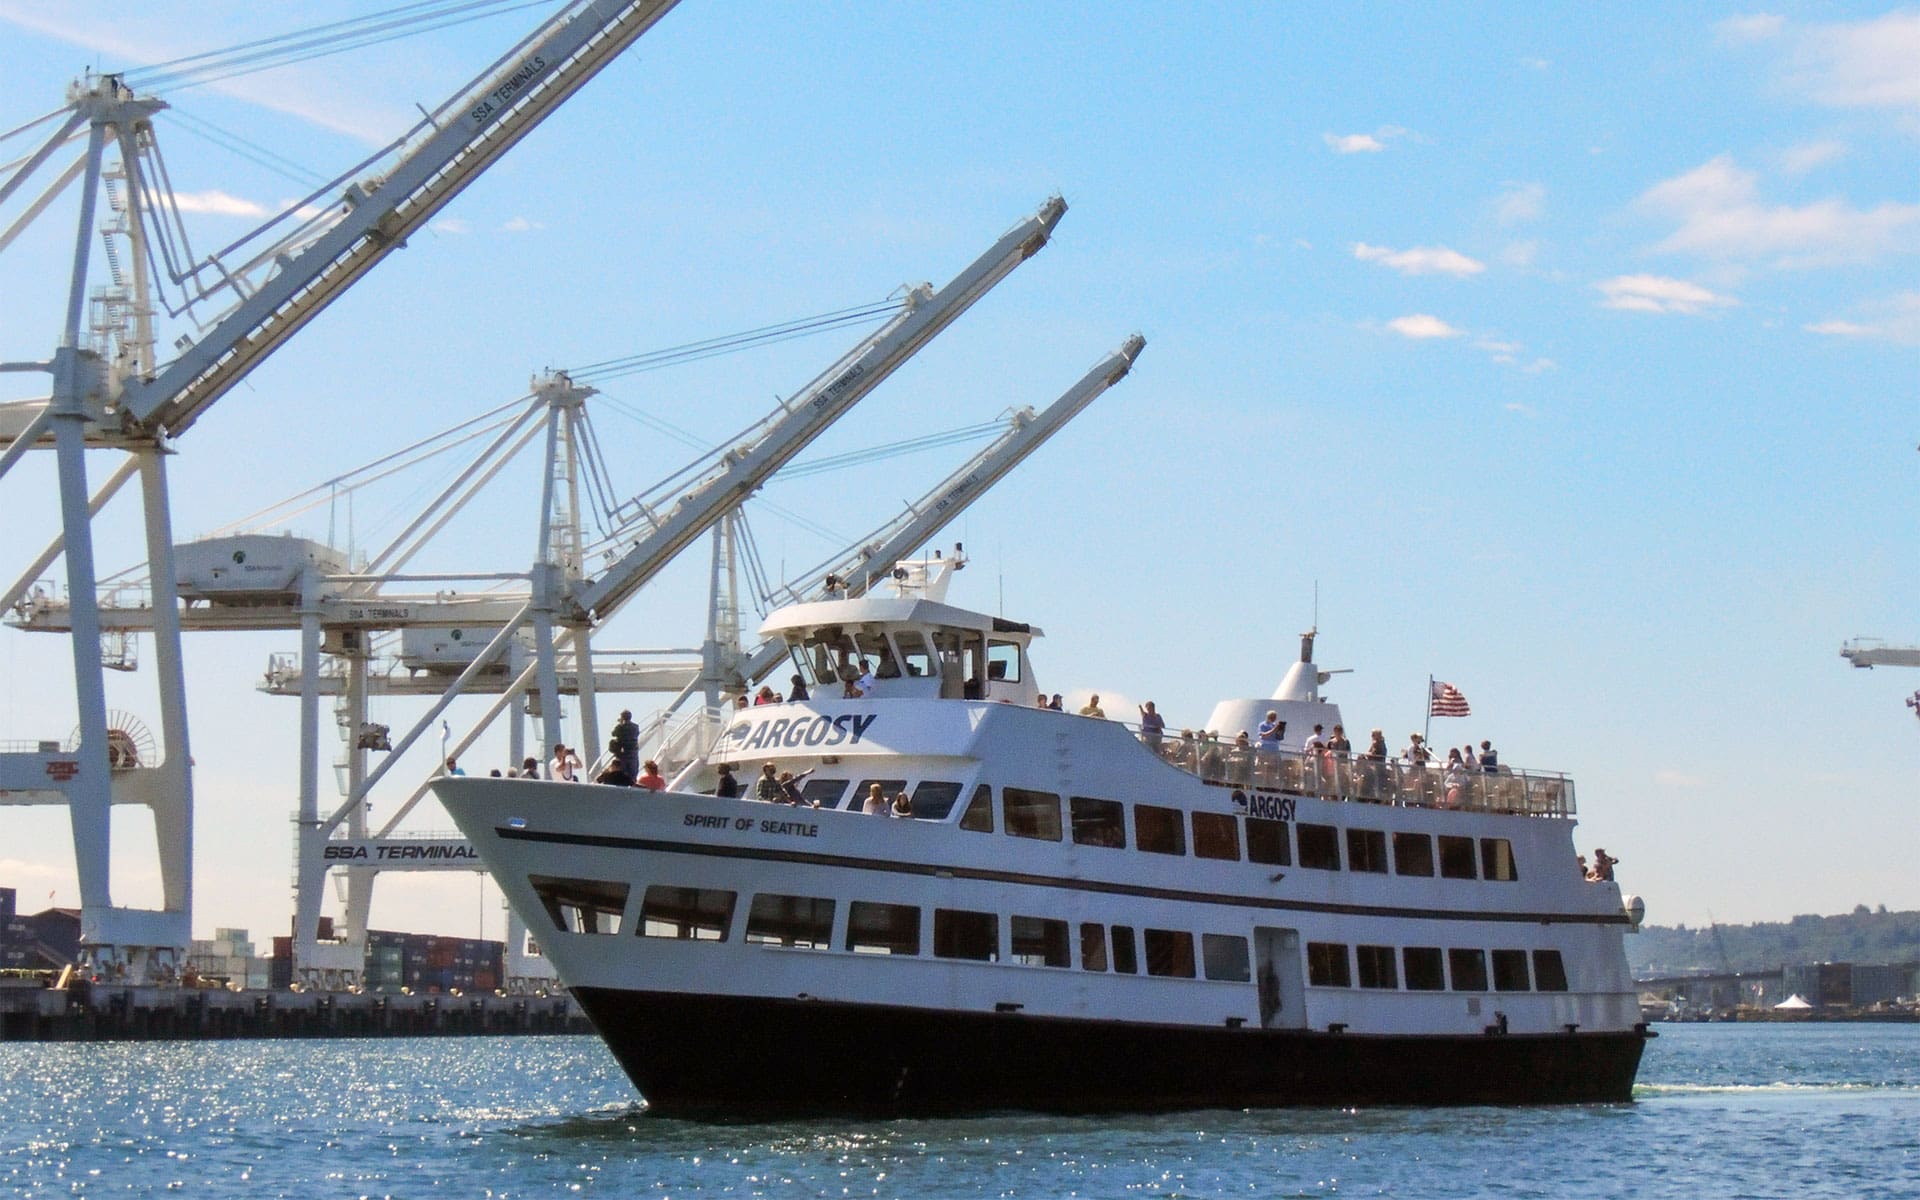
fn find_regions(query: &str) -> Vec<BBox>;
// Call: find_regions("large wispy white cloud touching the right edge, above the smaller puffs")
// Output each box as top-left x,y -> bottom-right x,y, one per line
1634,154 -> 1920,267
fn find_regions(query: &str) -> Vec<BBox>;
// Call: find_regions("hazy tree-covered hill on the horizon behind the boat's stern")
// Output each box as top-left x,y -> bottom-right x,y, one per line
1626,904 -> 1920,979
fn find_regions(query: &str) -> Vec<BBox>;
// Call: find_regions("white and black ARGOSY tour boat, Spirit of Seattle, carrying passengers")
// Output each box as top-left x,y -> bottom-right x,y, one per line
434,559 -> 1651,1117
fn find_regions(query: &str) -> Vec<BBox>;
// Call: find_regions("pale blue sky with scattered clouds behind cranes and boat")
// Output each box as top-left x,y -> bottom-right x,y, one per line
0,0 -> 1920,935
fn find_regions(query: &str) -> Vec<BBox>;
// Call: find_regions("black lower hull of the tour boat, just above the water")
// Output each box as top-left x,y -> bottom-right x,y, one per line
574,989 -> 1647,1119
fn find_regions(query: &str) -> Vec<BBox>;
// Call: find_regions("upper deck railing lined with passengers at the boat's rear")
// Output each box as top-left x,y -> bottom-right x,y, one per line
1131,726 -> 1574,816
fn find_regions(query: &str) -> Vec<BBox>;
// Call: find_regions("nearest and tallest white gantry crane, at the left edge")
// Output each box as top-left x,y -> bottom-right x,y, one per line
0,0 -> 676,979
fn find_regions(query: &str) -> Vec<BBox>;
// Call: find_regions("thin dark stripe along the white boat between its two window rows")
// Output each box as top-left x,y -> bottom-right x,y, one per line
493,826 -> 1632,925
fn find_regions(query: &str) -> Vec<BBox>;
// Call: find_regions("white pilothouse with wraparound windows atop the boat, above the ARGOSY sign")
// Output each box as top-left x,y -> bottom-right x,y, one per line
760,559 -> 1041,705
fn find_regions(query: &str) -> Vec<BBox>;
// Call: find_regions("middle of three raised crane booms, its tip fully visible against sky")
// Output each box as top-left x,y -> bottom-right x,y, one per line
572,196 -> 1068,616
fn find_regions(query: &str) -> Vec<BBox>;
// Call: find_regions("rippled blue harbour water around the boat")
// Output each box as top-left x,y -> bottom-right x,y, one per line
0,1025 -> 1920,1200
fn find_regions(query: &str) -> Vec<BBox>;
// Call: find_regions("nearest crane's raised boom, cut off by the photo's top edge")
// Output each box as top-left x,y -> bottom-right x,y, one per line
119,0 -> 678,434
